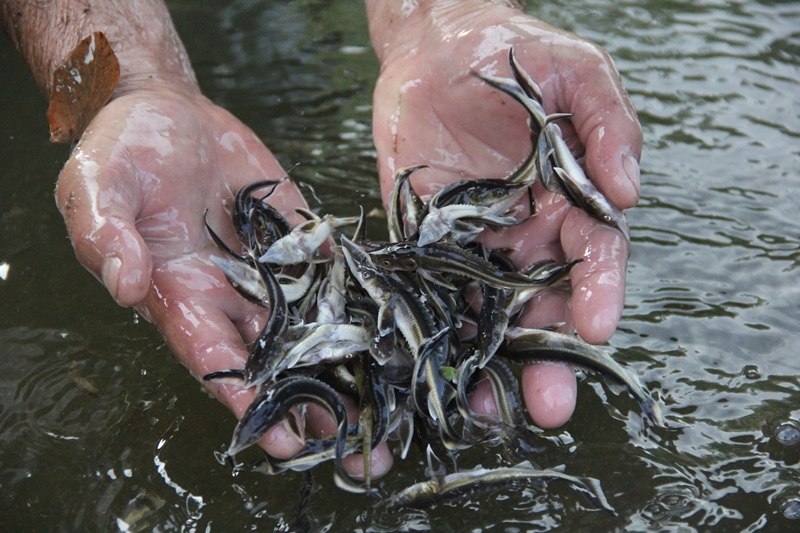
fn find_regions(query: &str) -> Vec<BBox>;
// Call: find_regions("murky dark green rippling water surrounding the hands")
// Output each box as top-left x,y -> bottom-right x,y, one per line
0,0 -> 800,531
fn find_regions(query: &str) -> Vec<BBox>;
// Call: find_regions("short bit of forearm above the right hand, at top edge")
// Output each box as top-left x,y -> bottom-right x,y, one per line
365,0 -> 525,59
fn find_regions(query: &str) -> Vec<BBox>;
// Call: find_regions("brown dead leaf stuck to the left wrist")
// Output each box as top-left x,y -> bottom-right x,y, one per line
47,31 -> 119,143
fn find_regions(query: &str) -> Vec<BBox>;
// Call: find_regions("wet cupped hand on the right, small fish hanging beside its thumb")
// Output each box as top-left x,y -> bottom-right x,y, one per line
372,0 -> 642,427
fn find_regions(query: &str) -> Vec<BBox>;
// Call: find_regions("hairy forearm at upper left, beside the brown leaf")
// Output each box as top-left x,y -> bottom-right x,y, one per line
0,0 -> 199,96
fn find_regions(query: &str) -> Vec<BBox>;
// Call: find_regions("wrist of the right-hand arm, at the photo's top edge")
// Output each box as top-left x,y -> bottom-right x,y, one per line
366,0 -> 526,63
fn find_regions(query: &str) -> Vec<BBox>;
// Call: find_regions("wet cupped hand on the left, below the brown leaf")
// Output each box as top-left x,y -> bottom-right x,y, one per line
56,86 -> 391,477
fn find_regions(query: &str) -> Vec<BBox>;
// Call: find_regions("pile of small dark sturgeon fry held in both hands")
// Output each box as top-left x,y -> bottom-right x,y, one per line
205,52 -> 663,510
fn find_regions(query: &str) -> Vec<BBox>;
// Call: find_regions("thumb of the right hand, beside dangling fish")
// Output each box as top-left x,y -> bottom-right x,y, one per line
564,42 -> 642,209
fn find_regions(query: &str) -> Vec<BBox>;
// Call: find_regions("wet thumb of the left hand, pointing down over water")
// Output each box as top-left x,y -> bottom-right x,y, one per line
56,145 -> 152,306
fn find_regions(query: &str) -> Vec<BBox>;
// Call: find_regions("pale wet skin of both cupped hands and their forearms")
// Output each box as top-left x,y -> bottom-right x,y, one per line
2,0 -> 642,477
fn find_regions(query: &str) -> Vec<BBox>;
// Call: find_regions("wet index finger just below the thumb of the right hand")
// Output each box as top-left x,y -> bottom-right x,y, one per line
561,209 -> 630,344
